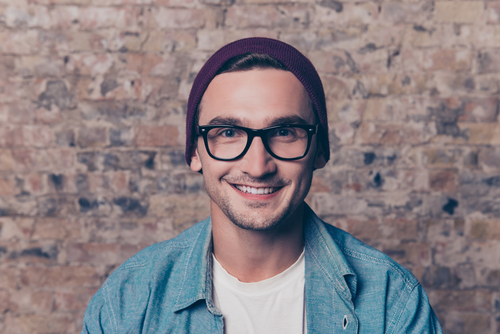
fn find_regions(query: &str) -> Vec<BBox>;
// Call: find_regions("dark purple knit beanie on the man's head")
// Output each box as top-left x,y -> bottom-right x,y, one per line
186,37 -> 330,165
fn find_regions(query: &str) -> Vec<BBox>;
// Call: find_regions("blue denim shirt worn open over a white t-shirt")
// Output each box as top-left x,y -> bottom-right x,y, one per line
82,207 -> 442,334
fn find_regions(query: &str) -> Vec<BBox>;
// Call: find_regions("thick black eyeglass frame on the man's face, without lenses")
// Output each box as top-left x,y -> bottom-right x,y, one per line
196,124 -> 320,161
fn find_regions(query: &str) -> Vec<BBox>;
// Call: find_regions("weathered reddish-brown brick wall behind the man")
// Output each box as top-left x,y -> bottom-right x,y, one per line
0,0 -> 500,334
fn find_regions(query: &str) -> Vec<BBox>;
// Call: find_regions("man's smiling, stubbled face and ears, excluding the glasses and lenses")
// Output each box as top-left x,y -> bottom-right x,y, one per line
191,69 -> 325,230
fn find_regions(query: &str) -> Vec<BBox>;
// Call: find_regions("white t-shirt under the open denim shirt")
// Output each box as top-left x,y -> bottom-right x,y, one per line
213,252 -> 306,334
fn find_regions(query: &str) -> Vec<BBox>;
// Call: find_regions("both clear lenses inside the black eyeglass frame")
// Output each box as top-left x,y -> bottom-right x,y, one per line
206,127 -> 309,159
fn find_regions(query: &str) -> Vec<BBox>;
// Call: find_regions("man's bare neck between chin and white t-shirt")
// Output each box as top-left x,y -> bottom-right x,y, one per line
212,203 -> 304,282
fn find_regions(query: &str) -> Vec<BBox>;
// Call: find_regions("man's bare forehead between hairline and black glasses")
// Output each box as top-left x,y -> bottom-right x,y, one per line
198,69 -> 315,126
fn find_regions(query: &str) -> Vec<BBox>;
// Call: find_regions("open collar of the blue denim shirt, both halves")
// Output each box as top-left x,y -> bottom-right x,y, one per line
170,204 -> 357,316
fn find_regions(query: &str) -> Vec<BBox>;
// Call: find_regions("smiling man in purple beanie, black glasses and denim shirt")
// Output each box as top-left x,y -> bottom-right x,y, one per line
82,38 -> 441,334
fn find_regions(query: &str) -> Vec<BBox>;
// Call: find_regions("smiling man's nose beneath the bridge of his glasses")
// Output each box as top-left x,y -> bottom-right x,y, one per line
240,136 -> 276,178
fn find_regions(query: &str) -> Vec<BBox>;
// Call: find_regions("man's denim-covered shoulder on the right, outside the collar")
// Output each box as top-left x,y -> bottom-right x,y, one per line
321,221 -> 442,333
